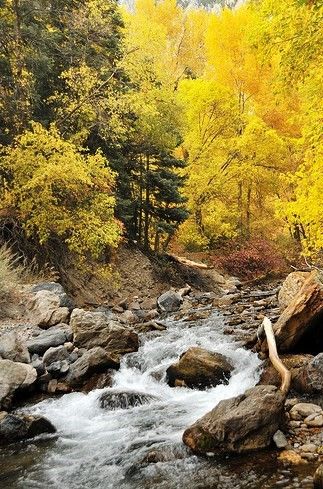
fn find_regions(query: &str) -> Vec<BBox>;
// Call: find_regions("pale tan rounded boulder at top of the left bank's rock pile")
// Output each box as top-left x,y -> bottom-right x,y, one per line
29,290 -> 70,329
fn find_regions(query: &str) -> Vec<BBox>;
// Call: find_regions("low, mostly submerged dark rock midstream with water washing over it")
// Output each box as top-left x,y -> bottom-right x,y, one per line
99,390 -> 156,410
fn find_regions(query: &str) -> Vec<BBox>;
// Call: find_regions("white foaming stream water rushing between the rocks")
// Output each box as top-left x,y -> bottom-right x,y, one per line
0,312 -> 316,489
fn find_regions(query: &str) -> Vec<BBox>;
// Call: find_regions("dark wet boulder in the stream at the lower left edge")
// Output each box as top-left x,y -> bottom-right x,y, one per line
0,411 -> 56,445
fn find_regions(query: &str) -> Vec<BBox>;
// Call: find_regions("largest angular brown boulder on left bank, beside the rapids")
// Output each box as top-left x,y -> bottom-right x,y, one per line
70,309 -> 139,354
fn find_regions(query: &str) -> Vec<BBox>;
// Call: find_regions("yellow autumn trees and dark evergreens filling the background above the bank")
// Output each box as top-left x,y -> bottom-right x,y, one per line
0,0 -> 323,261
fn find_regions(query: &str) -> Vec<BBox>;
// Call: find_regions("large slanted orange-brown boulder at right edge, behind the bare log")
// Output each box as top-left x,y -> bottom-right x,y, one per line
261,270 -> 323,353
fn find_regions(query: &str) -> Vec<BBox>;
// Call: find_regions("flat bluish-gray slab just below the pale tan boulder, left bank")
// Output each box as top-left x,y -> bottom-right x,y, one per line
27,324 -> 73,355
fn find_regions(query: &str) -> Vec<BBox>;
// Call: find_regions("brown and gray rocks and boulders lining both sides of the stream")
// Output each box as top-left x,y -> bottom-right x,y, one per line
0,268 -> 323,487
